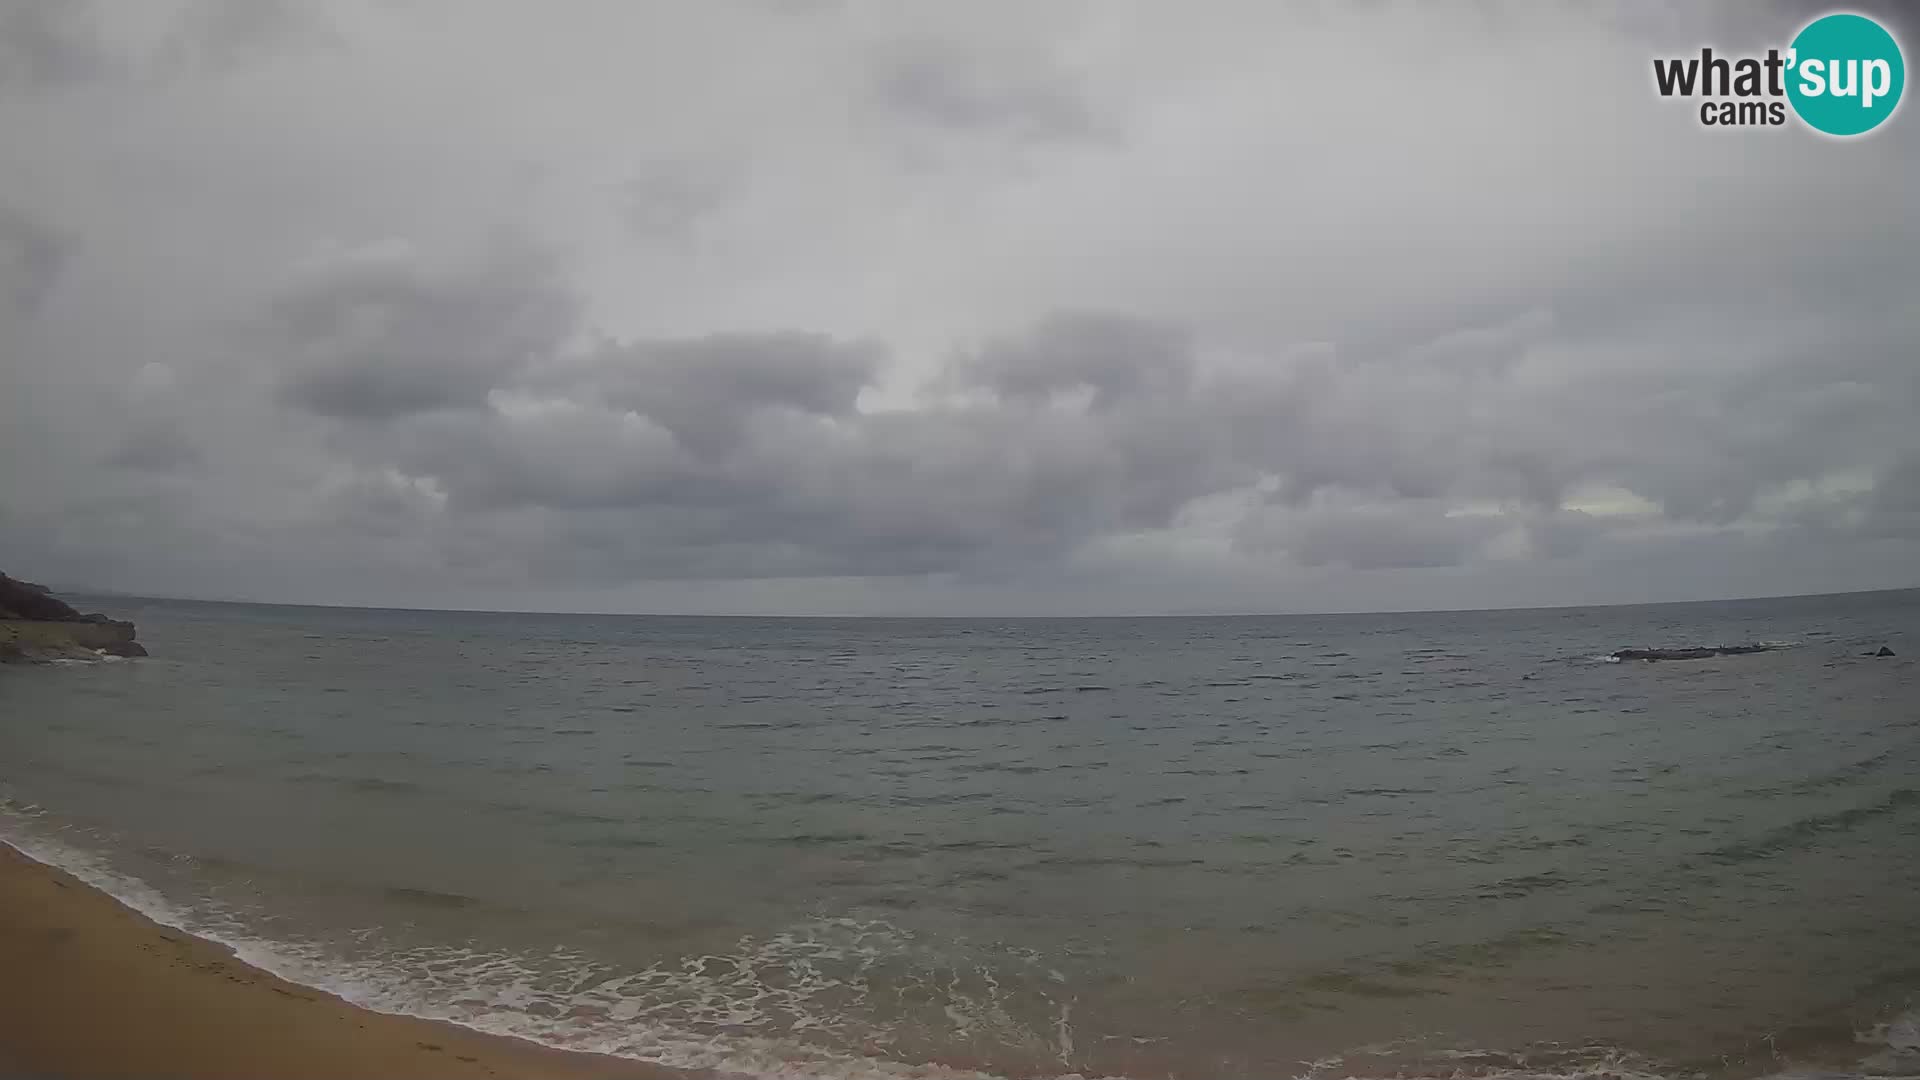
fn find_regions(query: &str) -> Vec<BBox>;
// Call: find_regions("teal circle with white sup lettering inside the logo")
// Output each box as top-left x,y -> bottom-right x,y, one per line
1788,13 -> 1907,136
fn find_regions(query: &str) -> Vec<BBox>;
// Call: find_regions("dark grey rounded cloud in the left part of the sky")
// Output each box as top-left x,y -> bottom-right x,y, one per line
270,250 -> 574,421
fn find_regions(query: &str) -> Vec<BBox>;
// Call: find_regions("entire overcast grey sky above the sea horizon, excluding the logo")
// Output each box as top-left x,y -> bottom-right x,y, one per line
0,0 -> 1920,617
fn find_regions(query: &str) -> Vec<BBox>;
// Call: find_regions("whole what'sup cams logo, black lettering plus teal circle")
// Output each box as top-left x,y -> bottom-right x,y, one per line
1653,12 -> 1907,136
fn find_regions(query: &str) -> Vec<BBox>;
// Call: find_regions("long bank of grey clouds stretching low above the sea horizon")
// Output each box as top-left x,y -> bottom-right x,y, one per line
278,261 -> 1920,580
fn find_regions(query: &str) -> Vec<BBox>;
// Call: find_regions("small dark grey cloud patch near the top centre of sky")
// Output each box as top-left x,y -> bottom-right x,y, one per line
870,40 -> 1102,140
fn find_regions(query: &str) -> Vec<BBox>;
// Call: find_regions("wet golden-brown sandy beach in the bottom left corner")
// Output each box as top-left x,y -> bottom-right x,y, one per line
0,846 -> 680,1080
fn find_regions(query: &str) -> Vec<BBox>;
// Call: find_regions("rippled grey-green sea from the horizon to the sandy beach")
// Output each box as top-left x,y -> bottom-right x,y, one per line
0,590 -> 1920,1080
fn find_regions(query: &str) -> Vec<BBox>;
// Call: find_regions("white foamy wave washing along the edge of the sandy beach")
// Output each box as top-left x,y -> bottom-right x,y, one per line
0,826 -> 1071,1080
